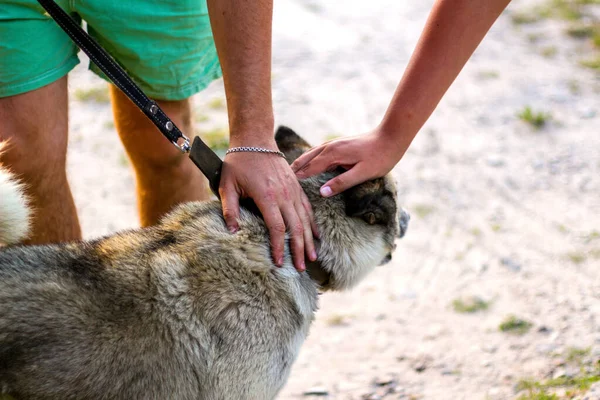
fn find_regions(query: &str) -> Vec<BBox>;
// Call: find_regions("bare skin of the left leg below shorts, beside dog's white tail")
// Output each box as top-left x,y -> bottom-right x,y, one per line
0,76 -> 81,244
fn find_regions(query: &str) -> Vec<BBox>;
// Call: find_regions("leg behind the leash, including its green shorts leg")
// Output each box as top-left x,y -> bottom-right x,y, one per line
76,0 -> 221,226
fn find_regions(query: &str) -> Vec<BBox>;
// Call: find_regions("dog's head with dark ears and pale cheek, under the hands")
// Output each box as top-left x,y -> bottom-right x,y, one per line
275,127 -> 410,290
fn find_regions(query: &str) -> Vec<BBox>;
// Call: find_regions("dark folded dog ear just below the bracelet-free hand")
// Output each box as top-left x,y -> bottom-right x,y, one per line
343,178 -> 396,225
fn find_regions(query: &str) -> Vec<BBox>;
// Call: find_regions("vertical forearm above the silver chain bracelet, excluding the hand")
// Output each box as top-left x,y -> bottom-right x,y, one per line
208,0 -> 274,146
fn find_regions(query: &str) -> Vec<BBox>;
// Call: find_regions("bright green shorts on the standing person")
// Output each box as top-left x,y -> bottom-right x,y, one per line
0,0 -> 221,100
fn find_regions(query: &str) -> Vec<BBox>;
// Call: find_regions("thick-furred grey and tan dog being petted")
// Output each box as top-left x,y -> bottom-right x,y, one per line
0,127 -> 409,400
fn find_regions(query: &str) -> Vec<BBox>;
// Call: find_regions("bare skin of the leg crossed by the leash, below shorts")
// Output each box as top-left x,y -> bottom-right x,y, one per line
110,85 -> 208,226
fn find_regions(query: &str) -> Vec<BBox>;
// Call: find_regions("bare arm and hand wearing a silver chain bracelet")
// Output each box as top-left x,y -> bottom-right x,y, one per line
208,0 -> 316,270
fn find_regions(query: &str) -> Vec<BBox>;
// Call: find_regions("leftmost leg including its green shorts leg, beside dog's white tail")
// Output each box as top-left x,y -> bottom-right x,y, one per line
0,0 -> 81,244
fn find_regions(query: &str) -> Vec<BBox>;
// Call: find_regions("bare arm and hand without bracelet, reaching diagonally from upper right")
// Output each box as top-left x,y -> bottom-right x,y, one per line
292,0 -> 510,196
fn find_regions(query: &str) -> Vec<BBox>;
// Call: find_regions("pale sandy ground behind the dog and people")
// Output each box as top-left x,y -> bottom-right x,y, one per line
63,0 -> 600,399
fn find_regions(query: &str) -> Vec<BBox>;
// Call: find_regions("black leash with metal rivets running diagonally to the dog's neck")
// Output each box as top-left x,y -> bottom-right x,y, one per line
38,0 -> 223,198
